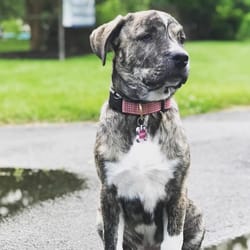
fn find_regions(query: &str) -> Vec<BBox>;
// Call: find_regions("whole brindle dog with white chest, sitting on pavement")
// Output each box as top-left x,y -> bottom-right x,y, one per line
90,10 -> 205,250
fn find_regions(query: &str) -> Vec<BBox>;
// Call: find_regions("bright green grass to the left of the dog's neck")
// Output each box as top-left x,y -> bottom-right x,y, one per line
0,56 -> 109,123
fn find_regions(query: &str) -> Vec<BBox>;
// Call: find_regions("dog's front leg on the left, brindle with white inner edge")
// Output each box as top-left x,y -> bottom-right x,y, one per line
101,187 -> 124,250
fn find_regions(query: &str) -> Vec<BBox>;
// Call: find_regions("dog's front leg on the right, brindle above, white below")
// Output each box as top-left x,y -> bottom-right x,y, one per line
161,198 -> 186,250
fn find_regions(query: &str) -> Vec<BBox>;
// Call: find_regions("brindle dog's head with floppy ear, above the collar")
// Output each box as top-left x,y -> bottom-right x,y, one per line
90,10 -> 189,101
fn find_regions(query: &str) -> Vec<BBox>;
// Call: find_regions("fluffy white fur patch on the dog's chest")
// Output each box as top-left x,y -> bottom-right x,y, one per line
106,138 -> 178,212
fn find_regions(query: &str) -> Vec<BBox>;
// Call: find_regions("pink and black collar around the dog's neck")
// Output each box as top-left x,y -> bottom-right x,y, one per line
109,90 -> 172,116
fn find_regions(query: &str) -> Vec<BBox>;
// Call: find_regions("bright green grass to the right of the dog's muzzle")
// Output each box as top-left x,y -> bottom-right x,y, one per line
176,42 -> 250,115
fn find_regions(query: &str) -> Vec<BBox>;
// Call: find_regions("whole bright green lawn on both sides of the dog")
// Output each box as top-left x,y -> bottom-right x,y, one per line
0,42 -> 250,124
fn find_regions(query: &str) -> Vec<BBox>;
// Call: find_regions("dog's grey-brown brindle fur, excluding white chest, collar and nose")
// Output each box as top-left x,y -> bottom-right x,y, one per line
90,11 -> 204,250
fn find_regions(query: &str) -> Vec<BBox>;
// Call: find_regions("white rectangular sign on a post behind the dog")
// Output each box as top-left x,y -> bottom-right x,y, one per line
63,0 -> 95,27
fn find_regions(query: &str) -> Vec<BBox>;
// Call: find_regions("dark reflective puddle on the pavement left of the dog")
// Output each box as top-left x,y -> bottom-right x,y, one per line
0,168 -> 87,222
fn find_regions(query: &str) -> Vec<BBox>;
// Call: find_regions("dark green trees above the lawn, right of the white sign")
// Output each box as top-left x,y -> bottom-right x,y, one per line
97,0 -> 250,39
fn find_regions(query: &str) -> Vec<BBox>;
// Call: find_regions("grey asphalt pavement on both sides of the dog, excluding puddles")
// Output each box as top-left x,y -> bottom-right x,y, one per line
0,108 -> 250,250
